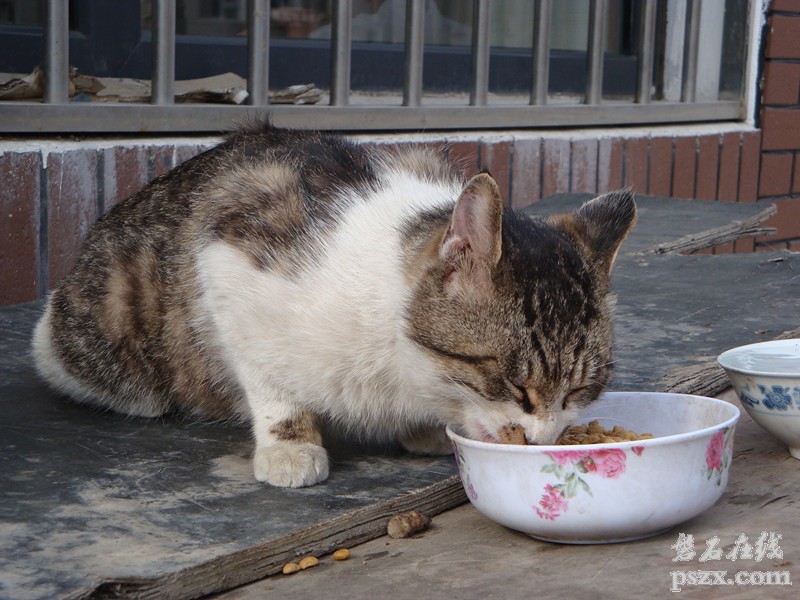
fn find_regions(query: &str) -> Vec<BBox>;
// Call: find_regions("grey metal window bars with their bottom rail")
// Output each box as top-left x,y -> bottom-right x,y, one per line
0,0 -> 745,133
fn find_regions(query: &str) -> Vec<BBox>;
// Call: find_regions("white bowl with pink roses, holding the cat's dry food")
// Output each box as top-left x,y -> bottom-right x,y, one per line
447,392 -> 739,544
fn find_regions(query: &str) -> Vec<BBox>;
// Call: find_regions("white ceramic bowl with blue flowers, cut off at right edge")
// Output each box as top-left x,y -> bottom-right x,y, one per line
717,339 -> 800,459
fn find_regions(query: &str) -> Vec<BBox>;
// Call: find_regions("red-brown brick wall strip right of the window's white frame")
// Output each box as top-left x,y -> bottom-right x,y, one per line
757,0 -> 800,250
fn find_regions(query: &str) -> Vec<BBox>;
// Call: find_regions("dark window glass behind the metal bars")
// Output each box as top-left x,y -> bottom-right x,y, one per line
0,0 -> 750,129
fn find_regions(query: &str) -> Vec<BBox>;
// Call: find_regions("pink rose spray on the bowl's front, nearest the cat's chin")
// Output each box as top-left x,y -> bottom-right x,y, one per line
533,446 -> 644,521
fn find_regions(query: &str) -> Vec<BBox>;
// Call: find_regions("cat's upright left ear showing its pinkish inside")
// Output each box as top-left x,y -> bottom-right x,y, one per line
439,173 -> 503,295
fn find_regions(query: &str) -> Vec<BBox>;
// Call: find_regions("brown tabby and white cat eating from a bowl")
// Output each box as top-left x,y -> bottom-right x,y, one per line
33,124 -> 636,487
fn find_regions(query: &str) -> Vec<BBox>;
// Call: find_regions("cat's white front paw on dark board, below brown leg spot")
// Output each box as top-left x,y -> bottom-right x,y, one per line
253,442 -> 328,487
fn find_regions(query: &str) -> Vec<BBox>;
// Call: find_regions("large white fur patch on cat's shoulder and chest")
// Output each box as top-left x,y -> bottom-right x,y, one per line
198,172 -> 466,442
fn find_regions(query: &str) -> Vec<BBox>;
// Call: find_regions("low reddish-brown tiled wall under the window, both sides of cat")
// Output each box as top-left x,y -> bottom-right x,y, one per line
0,126 -> 763,305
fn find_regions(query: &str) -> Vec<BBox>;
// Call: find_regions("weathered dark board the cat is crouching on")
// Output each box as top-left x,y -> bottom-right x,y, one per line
0,196 -> 800,598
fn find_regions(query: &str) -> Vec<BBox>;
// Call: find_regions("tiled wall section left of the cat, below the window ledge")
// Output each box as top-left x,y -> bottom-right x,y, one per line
0,140 -> 216,306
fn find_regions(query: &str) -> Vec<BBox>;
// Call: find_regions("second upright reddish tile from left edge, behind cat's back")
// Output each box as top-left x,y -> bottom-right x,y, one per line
47,150 -> 98,289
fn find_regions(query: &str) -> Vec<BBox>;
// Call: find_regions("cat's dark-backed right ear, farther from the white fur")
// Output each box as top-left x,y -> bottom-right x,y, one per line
555,188 -> 636,273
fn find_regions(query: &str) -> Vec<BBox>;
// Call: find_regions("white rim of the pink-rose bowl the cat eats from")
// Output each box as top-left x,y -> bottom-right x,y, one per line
445,391 -> 742,454
